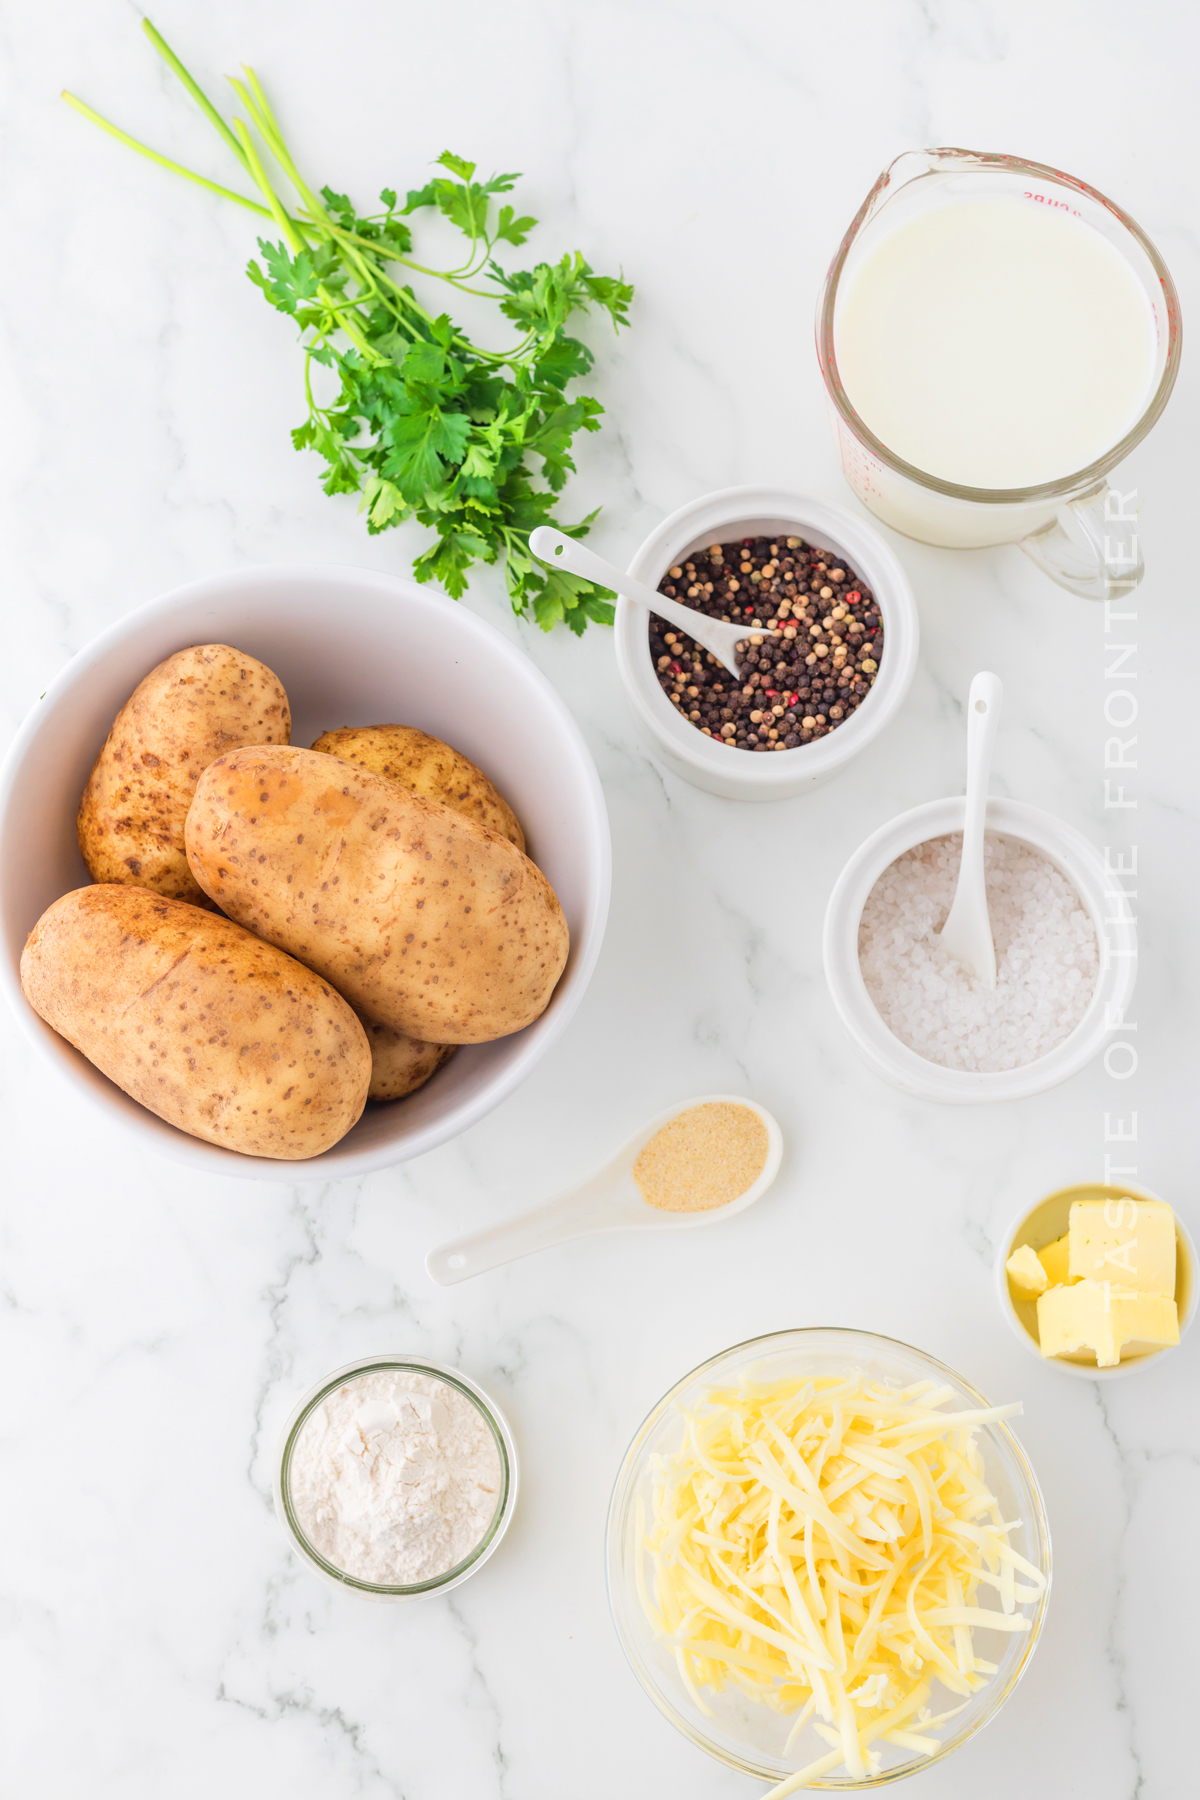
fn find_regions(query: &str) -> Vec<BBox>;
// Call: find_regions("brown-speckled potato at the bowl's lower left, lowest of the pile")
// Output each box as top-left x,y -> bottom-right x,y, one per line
22,884 -> 371,1161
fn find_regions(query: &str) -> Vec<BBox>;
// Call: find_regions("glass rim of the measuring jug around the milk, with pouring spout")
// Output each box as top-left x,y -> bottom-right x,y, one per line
817,146 -> 1182,506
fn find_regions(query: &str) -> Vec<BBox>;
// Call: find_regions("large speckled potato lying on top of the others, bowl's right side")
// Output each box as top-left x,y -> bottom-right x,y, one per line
185,745 -> 569,1044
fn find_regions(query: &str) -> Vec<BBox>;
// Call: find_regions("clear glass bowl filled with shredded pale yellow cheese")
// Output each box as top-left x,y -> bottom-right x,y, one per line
608,1328 -> 1051,1800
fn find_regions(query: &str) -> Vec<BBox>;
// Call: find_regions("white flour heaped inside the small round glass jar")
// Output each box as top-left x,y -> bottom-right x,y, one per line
288,1370 -> 502,1588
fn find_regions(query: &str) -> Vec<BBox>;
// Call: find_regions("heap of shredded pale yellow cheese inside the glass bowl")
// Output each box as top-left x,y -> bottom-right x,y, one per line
639,1372 -> 1045,1800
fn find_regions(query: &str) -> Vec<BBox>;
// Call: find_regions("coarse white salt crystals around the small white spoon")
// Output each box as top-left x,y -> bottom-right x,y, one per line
858,832 -> 1099,1075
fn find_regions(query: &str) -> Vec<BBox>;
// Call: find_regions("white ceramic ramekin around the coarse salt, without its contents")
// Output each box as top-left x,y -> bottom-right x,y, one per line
824,796 -> 1137,1103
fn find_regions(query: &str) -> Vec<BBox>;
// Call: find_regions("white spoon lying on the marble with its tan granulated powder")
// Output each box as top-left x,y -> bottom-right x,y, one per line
425,1094 -> 783,1287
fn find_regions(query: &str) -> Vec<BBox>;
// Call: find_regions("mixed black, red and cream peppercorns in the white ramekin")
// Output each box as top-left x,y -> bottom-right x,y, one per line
649,538 -> 883,751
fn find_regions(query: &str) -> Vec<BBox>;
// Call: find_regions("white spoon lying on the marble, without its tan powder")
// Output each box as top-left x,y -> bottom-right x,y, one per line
425,1094 -> 783,1287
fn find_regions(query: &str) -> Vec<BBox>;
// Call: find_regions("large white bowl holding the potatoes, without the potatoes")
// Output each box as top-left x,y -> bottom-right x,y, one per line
0,565 -> 612,1181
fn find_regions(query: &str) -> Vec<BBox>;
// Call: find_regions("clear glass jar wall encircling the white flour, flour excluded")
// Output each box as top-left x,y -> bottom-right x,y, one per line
275,1354 -> 516,1600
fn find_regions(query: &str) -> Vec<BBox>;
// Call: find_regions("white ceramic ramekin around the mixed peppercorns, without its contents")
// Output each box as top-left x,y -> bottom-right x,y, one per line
617,488 -> 919,799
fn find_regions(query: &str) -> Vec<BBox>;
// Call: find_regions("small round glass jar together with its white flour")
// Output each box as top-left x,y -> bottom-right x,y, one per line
275,1355 -> 516,1600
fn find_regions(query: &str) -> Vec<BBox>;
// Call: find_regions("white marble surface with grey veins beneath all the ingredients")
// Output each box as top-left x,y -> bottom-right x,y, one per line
0,0 -> 1200,1800
